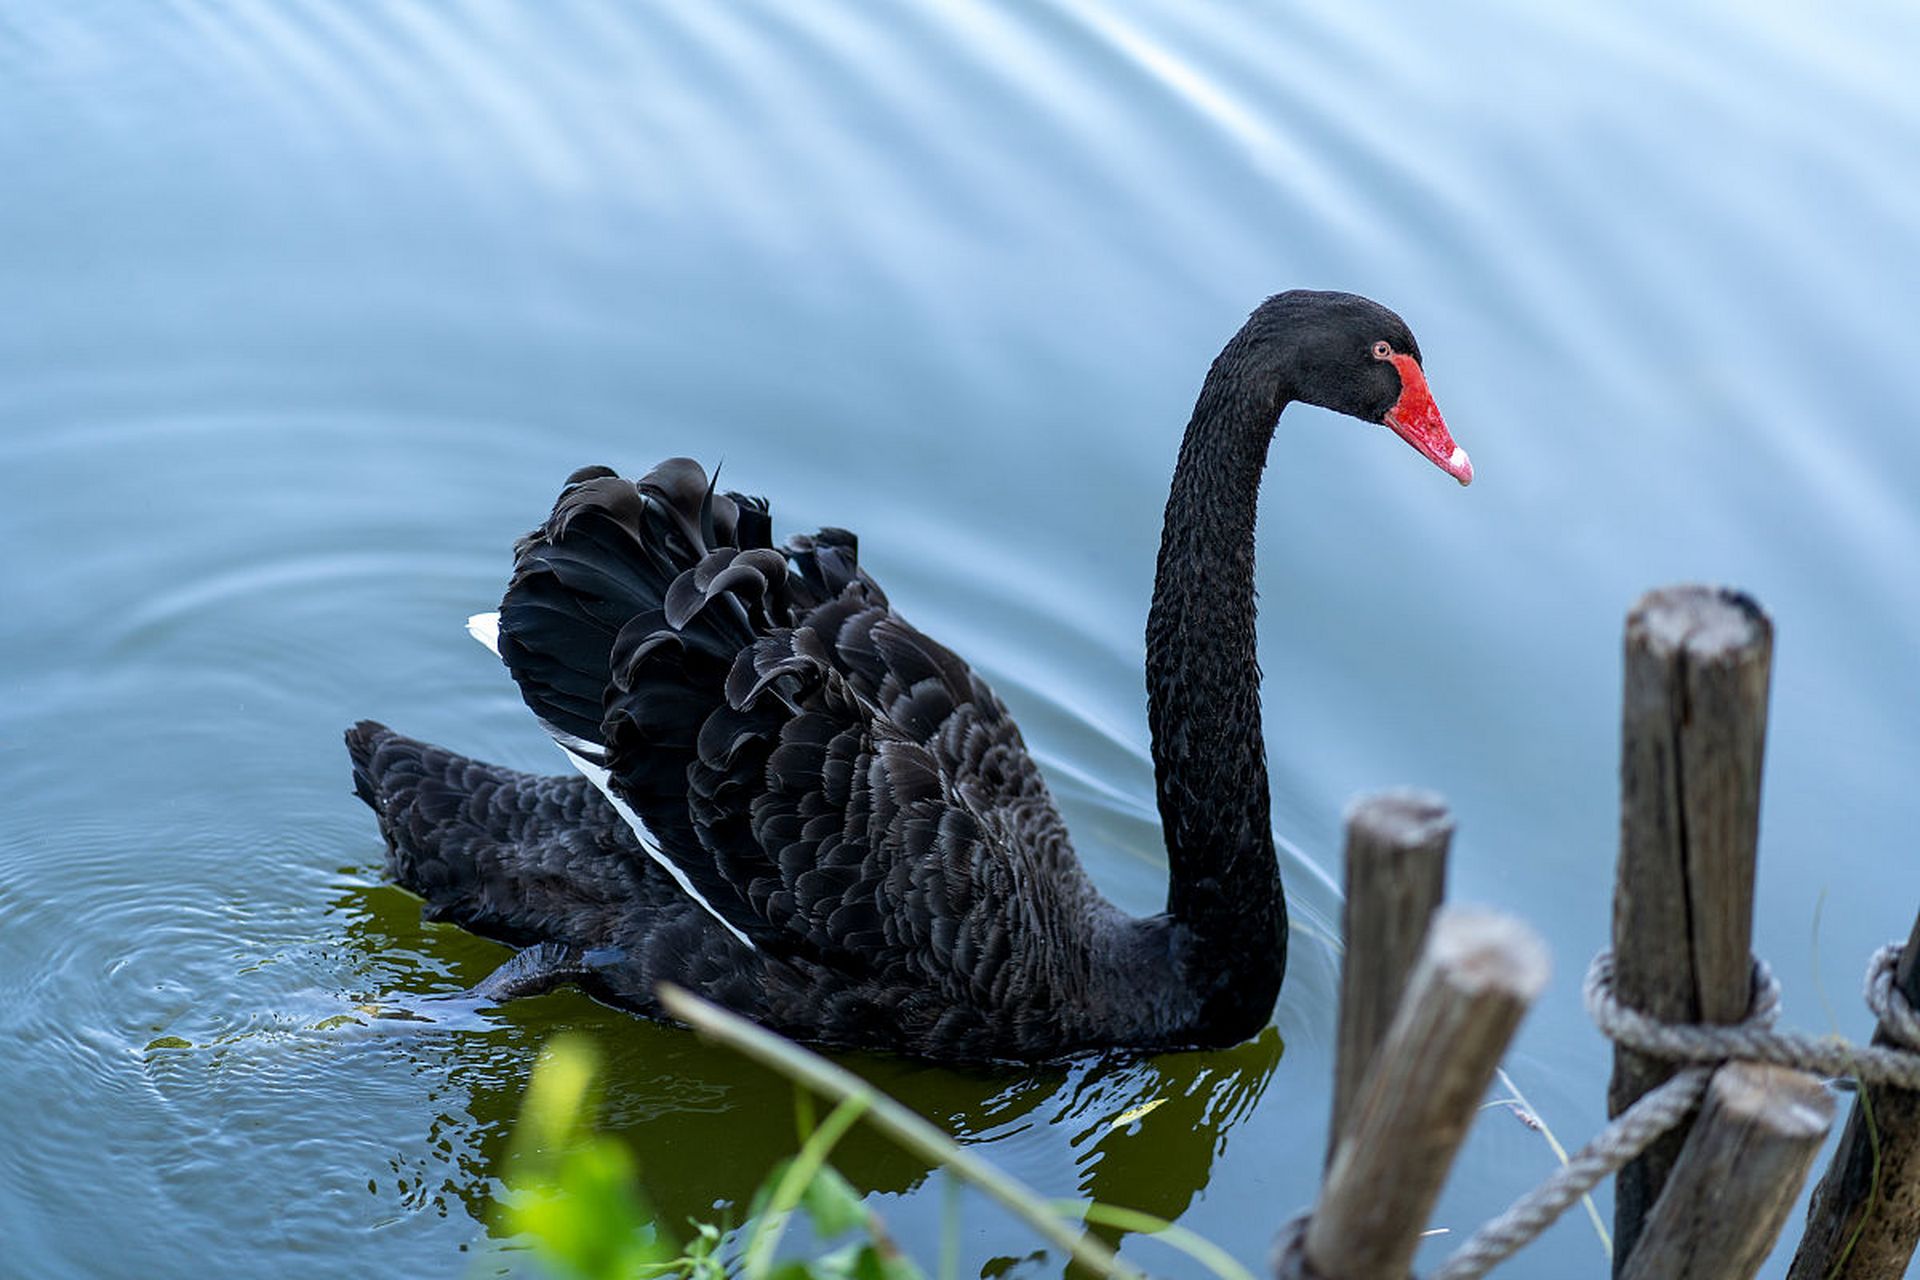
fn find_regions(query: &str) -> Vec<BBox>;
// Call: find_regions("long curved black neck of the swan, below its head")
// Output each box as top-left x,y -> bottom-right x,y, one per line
1146,344 -> 1286,1038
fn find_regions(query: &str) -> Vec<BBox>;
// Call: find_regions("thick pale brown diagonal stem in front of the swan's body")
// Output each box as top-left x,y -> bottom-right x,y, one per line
660,983 -> 1144,1280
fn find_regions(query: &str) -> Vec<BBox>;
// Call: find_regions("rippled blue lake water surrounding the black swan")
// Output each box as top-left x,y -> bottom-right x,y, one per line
0,0 -> 1920,1276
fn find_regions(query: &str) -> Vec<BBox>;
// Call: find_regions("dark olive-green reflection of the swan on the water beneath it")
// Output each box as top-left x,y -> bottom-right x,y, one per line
334,885 -> 1283,1274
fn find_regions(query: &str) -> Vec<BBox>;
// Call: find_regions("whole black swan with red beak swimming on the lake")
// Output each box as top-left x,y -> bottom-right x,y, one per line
348,292 -> 1473,1061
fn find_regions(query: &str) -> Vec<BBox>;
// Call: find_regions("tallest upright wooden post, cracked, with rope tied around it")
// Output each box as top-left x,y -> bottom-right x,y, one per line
1607,587 -> 1774,1274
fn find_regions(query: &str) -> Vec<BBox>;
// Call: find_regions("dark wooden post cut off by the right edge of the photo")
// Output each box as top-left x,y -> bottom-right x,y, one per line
1788,919 -> 1920,1280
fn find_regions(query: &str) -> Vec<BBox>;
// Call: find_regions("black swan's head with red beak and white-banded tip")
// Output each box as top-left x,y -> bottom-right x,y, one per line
1242,290 -> 1473,484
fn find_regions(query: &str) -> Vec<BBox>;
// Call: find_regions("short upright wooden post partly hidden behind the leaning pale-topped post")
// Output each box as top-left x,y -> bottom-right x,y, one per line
1327,791 -> 1453,1165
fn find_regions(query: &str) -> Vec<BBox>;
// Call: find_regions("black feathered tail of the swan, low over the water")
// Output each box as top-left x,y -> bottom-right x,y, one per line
346,720 -> 645,946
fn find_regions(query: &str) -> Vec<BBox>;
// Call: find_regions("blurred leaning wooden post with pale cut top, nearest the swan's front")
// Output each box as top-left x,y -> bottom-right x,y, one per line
1302,908 -> 1548,1280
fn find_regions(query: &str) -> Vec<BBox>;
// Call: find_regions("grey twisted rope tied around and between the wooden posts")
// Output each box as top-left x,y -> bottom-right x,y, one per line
1328,942 -> 1920,1280
